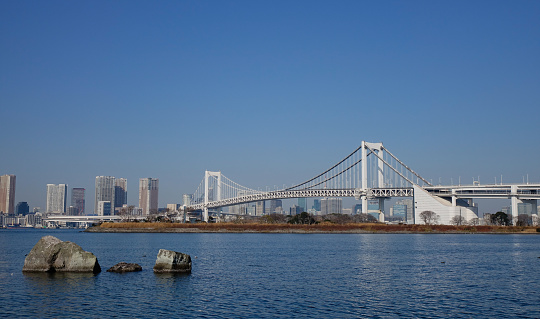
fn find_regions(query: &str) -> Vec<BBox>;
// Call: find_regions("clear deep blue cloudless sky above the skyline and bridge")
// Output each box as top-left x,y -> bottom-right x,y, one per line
0,0 -> 540,215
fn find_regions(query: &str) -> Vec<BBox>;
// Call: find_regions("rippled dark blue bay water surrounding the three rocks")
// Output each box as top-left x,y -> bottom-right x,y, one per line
0,229 -> 540,318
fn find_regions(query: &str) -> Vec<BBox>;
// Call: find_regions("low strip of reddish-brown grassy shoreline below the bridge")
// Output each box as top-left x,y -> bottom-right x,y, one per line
86,222 -> 540,235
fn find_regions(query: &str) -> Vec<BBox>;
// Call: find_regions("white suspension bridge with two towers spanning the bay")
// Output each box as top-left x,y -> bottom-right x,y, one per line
184,141 -> 540,224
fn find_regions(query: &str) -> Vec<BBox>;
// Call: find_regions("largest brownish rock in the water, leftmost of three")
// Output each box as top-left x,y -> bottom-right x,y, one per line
23,236 -> 101,273
